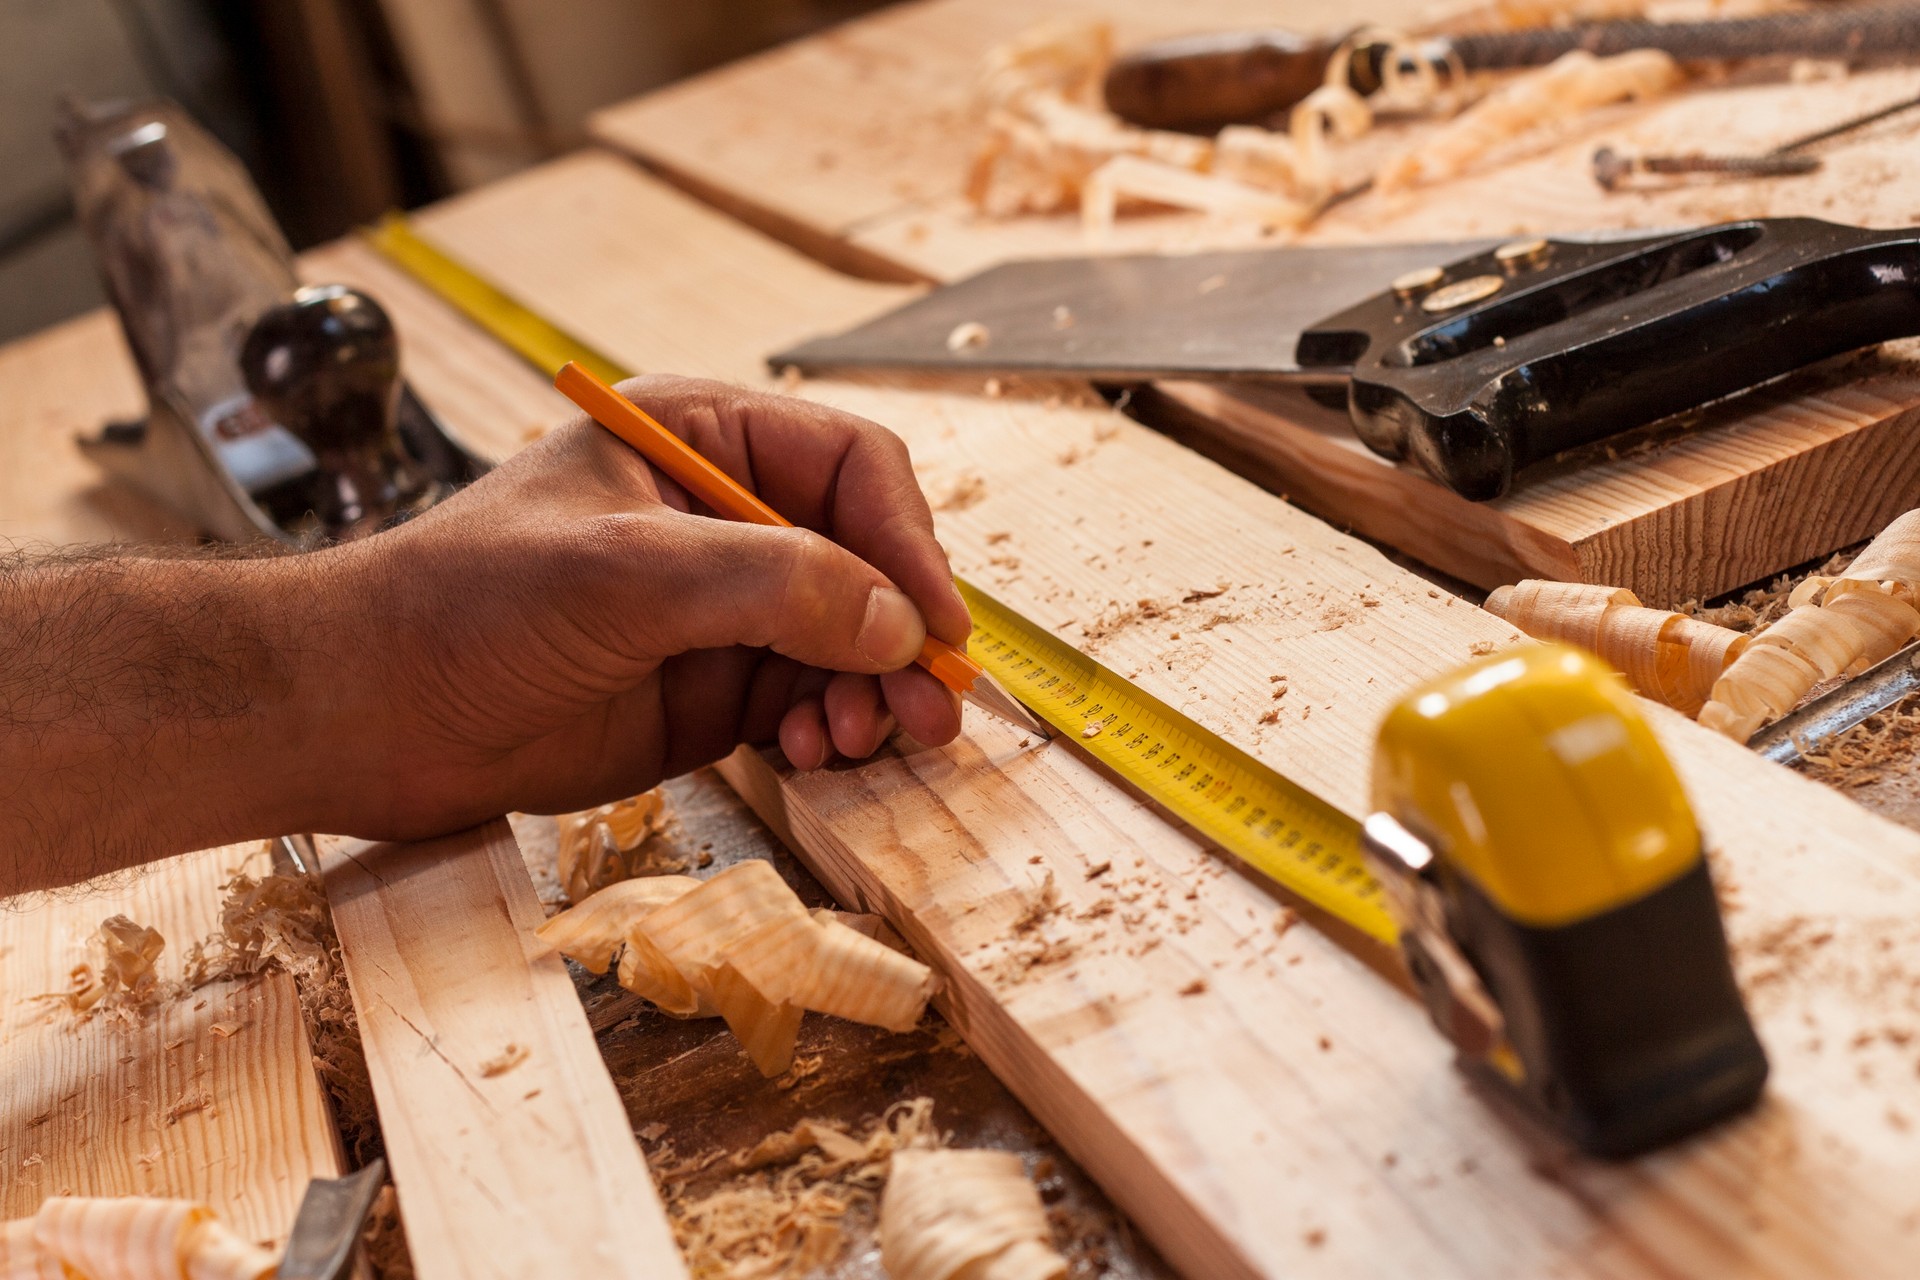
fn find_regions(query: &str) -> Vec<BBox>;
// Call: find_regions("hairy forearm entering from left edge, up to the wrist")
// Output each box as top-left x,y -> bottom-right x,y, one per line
0,553 -> 360,894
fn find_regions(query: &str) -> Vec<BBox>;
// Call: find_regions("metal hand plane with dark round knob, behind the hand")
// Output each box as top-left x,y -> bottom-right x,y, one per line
56,102 -> 486,545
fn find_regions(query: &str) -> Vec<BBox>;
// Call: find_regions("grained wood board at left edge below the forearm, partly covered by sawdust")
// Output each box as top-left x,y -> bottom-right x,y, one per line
0,844 -> 344,1244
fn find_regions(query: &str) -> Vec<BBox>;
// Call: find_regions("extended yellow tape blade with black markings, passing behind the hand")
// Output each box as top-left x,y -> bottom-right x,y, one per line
367,215 -> 1400,944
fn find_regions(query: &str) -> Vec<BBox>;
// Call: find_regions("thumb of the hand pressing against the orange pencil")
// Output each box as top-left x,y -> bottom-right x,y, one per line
655,516 -> 927,672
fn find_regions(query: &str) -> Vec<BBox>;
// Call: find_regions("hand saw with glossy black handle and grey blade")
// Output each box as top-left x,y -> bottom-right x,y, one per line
770,219 -> 1920,501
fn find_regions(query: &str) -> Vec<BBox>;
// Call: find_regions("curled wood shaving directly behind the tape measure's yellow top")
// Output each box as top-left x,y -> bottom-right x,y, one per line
1486,580 -> 1749,716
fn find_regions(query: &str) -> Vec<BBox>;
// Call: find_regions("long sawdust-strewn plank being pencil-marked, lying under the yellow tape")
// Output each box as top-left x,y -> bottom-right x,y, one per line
408,147 -> 1920,1278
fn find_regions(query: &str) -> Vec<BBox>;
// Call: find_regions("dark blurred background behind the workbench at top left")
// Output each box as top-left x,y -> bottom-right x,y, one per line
0,0 -> 881,342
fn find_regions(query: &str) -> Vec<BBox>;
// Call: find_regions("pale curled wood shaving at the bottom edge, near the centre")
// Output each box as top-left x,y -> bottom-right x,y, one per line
879,1150 -> 1068,1280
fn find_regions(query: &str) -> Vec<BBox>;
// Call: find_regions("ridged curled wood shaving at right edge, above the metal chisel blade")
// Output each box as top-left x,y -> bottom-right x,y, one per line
1699,510 -> 1920,741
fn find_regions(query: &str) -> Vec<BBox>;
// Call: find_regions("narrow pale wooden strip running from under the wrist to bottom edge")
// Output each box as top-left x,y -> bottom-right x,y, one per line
321,819 -> 685,1280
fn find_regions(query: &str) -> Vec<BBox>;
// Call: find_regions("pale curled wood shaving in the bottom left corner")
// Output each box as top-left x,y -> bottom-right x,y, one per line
0,1196 -> 278,1280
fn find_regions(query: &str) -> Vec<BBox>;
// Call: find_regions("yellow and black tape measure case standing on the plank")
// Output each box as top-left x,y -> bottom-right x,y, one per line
1361,645 -> 1766,1157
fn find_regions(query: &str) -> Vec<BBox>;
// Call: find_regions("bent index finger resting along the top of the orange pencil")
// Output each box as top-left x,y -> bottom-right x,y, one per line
620,376 -> 972,645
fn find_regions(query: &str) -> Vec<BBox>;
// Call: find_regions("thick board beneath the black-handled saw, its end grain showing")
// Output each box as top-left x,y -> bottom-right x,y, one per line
593,0 -> 1920,603
